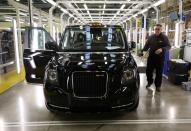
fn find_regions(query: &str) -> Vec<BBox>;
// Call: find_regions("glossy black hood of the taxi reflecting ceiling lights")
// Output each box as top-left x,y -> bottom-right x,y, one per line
57,52 -> 129,71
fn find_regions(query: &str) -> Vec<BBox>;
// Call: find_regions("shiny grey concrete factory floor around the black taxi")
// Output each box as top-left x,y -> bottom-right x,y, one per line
0,56 -> 191,131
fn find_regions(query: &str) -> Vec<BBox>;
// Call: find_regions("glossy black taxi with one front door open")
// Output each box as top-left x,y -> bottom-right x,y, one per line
24,25 -> 140,111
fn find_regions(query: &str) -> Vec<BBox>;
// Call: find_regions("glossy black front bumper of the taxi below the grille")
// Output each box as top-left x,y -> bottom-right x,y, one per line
44,80 -> 139,112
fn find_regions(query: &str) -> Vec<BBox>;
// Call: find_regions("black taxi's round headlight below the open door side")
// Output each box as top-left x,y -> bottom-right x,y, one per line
47,69 -> 58,83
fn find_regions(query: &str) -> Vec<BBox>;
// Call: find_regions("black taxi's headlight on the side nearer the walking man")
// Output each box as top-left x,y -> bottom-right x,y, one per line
121,69 -> 135,84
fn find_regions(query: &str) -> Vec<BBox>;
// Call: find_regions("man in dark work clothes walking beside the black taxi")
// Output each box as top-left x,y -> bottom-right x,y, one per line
143,24 -> 171,92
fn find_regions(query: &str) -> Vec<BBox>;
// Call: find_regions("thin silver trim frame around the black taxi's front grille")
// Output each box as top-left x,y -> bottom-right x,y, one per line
72,71 -> 108,99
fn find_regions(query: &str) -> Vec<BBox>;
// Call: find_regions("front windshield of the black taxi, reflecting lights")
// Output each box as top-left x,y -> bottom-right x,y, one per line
60,26 -> 125,51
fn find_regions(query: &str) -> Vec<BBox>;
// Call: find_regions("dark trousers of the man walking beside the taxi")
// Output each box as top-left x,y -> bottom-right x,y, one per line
146,56 -> 163,88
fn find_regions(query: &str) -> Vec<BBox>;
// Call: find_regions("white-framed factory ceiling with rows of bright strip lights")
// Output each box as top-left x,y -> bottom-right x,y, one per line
0,0 -> 165,24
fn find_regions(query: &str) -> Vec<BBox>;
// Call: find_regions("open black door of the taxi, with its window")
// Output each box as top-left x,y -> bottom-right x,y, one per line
23,27 -> 55,83
